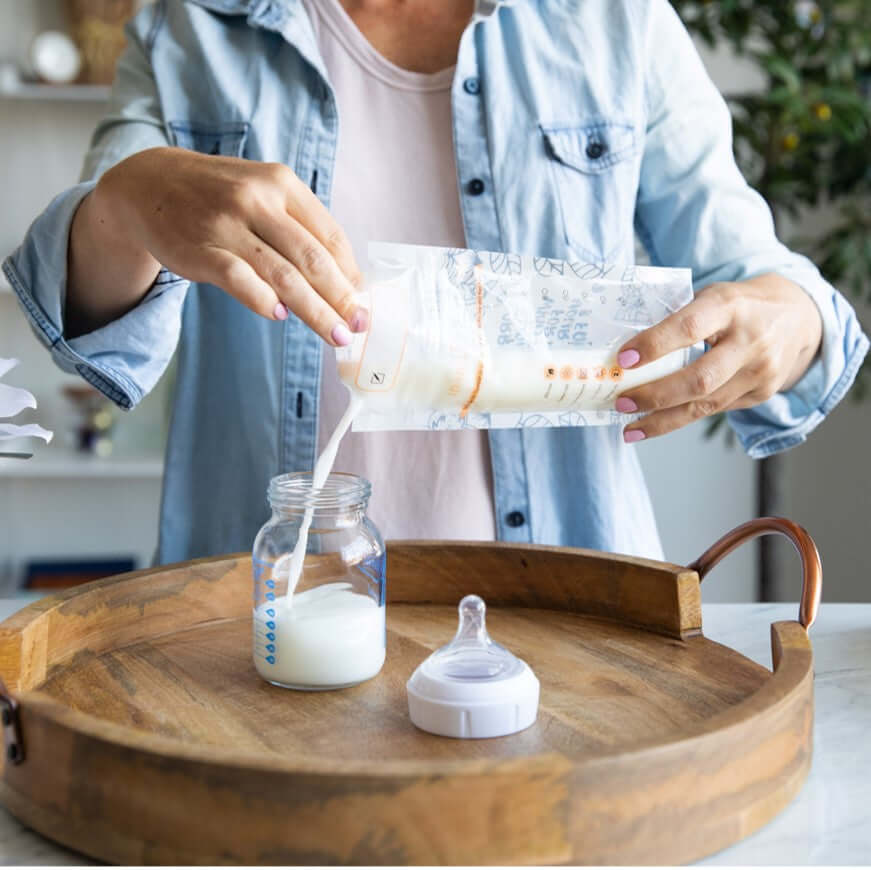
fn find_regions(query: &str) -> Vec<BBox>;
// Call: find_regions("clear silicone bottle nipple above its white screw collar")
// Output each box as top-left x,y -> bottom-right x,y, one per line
428,595 -> 521,680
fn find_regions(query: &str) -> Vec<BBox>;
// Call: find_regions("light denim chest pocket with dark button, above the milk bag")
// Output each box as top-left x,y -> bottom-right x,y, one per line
541,119 -> 639,263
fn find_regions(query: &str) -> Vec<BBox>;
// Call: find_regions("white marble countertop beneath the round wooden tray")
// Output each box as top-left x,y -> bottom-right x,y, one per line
0,599 -> 871,865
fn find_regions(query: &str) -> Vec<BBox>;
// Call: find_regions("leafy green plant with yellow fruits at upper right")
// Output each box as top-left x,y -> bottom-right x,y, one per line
672,0 -> 871,408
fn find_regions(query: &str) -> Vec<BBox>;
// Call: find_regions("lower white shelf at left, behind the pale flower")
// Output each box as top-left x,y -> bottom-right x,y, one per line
0,441 -> 163,481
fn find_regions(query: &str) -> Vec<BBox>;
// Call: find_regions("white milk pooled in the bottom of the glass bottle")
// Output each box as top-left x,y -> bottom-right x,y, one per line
254,583 -> 385,689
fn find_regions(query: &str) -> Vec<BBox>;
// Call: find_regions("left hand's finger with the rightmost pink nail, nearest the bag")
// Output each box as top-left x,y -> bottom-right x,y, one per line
253,216 -> 369,332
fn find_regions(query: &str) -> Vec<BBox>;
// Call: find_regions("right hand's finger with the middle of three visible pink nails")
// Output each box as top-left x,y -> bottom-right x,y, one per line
616,341 -> 746,414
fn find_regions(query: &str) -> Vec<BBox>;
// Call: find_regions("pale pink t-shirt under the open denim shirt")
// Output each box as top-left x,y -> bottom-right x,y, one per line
304,0 -> 496,540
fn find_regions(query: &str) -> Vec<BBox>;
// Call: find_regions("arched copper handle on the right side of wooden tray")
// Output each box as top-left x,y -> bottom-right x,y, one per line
687,517 -> 823,630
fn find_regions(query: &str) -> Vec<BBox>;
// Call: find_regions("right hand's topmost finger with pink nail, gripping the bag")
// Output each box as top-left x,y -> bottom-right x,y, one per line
617,287 -> 732,369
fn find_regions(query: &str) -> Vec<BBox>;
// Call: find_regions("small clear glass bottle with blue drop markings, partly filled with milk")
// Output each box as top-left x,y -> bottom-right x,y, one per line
253,472 -> 386,690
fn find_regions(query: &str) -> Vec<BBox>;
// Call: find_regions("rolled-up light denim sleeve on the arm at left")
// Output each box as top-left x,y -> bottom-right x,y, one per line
3,4 -> 188,410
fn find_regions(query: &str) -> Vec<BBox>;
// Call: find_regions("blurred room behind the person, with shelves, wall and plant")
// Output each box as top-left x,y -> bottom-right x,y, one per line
0,0 -> 871,601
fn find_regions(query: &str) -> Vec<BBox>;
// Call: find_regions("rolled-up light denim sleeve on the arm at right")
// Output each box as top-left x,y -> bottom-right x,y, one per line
636,0 -> 868,458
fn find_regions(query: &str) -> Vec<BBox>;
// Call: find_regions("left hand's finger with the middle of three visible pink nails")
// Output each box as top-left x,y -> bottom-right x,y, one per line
241,233 -> 353,347
